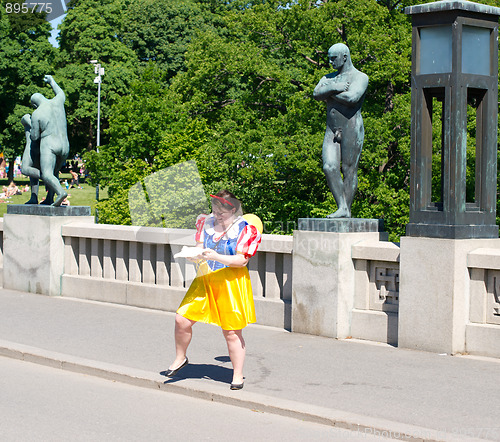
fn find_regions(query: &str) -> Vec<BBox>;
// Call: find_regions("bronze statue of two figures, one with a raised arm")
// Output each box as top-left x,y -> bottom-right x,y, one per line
21,75 -> 69,206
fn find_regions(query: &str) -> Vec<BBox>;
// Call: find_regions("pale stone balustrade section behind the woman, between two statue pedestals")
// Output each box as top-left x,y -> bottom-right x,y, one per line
61,223 -> 293,329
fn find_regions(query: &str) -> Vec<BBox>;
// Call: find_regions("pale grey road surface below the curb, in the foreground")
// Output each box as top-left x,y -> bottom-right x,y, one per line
0,357 -> 387,442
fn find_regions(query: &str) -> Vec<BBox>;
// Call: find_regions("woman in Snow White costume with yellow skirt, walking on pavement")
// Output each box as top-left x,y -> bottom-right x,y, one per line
166,190 -> 261,390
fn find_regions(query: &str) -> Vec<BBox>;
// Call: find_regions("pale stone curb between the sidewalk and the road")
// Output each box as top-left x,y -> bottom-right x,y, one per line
0,340 -> 484,442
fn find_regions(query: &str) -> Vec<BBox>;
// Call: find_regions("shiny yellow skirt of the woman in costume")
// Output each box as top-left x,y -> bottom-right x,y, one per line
177,262 -> 255,330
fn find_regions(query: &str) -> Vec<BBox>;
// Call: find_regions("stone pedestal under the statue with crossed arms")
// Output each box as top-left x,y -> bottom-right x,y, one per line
292,218 -> 388,339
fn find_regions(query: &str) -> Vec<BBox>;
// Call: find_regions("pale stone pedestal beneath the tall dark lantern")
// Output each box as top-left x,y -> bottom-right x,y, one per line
398,237 -> 500,354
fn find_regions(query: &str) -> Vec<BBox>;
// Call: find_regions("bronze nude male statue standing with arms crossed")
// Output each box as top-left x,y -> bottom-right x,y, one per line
313,43 -> 368,218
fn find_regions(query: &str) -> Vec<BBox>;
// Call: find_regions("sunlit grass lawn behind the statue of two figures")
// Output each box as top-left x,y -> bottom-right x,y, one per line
0,173 -> 108,217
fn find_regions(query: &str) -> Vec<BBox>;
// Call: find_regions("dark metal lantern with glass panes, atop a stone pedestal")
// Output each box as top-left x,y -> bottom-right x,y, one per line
405,0 -> 500,239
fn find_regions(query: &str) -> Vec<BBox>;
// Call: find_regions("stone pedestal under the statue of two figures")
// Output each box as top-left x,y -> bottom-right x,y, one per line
3,205 -> 94,296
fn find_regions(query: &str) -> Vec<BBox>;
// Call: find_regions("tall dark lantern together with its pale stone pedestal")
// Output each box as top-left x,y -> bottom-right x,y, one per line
398,0 -> 500,354
